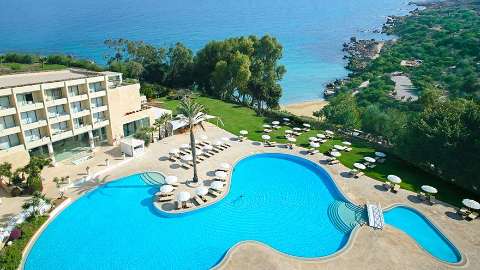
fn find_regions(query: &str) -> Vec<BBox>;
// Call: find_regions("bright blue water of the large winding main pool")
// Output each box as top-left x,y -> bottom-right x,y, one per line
25,154 -> 356,270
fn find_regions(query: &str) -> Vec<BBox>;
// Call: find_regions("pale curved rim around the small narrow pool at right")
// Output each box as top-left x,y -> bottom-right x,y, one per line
383,203 -> 468,268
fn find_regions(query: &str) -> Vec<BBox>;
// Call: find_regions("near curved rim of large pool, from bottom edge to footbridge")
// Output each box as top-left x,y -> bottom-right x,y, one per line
211,225 -> 363,270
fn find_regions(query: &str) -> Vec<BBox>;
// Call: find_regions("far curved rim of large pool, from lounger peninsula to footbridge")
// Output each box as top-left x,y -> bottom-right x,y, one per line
156,152 -> 362,217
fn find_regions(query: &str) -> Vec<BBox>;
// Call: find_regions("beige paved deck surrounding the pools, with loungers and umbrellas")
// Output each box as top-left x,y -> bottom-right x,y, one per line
0,124 -> 480,269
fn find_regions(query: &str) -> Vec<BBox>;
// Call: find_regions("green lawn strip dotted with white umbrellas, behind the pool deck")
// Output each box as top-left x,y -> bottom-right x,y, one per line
159,97 -> 478,206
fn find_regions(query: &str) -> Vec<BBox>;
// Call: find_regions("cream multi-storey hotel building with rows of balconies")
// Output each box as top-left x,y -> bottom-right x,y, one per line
0,69 -> 158,167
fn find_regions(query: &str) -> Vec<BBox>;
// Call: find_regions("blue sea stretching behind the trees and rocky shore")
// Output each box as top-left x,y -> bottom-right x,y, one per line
0,0 -> 415,103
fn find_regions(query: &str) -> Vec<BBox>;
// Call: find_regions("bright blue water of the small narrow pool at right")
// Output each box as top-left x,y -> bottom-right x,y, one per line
384,206 -> 462,263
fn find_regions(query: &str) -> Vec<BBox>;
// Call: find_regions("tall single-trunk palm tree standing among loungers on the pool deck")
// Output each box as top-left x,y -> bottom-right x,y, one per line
177,96 -> 205,183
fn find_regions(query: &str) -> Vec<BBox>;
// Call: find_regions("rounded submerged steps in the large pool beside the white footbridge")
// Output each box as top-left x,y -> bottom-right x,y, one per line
327,201 -> 367,233
